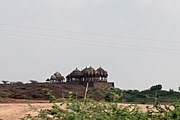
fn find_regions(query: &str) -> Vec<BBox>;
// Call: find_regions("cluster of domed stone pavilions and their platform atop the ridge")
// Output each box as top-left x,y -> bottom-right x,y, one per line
46,66 -> 114,88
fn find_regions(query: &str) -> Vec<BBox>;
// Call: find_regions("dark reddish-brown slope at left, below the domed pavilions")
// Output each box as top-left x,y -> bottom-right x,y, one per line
0,83 -> 85,100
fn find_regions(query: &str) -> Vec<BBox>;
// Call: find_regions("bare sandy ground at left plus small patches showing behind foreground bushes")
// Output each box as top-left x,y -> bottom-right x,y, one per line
0,99 -> 155,120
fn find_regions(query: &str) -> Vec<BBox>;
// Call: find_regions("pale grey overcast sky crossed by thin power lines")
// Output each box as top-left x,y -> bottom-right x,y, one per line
0,0 -> 180,90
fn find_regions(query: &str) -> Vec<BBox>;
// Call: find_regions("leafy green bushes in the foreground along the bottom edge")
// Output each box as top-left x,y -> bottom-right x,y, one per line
21,100 -> 180,120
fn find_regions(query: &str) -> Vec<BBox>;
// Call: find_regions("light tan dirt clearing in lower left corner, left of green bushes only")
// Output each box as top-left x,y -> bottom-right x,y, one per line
0,103 -> 53,120
